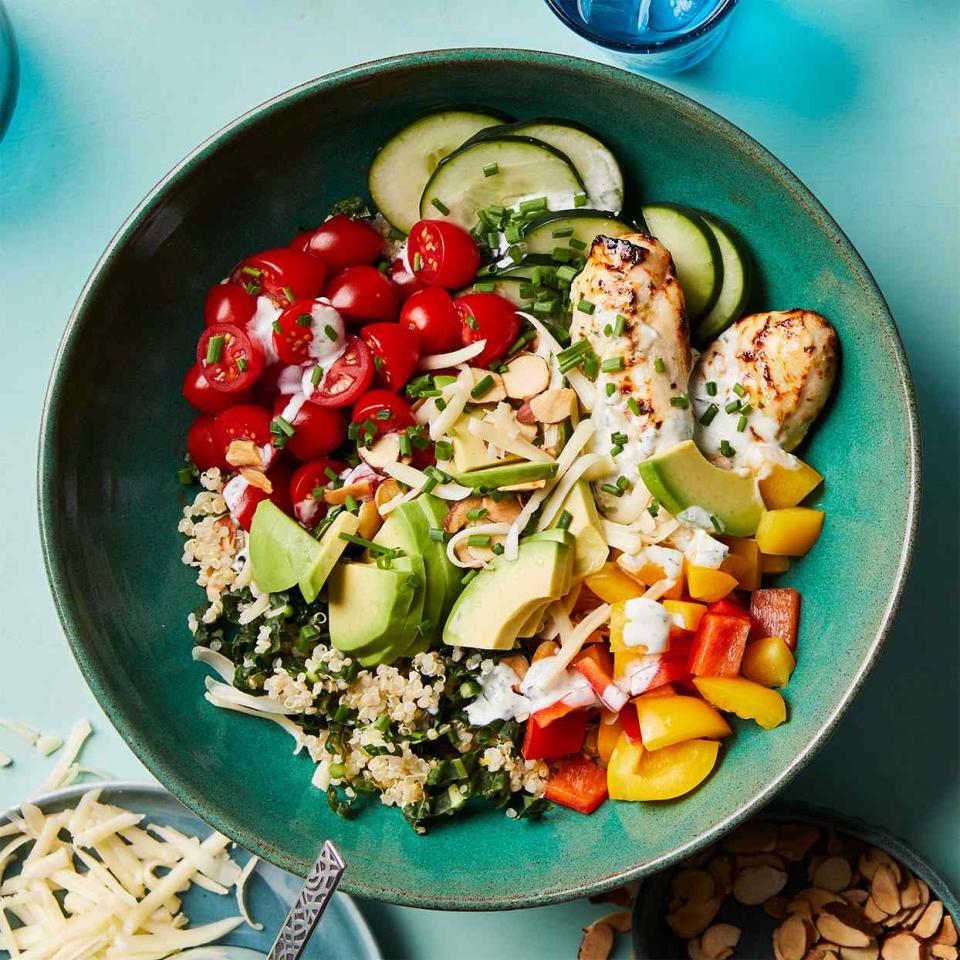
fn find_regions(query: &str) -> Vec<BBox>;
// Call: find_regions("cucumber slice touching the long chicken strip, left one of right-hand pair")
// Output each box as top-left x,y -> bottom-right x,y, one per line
643,203 -> 723,321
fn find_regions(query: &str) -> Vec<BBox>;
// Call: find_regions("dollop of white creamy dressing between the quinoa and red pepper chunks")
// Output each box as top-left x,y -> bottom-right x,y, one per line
466,657 -> 597,726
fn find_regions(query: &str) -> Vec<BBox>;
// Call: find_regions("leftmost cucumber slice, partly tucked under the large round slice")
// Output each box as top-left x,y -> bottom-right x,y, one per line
369,110 -> 503,233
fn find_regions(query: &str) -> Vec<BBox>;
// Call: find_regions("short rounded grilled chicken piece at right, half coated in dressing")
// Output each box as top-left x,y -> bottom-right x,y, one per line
690,310 -> 839,471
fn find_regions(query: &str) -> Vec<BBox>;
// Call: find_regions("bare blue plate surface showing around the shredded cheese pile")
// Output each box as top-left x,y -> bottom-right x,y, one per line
0,781 -> 383,960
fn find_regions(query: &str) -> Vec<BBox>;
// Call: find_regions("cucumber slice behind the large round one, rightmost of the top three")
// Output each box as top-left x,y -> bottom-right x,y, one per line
466,117 -> 623,213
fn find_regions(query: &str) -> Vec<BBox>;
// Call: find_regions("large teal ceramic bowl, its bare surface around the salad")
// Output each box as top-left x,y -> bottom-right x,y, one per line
39,50 -> 919,909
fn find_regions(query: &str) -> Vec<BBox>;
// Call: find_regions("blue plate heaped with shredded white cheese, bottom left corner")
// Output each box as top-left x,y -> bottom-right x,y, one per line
0,782 -> 381,960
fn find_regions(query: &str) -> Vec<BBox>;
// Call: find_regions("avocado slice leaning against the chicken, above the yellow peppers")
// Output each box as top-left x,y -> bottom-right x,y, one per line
639,440 -> 765,537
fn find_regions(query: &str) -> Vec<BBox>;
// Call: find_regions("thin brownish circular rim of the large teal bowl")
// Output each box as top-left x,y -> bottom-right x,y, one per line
37,47 -> 921,910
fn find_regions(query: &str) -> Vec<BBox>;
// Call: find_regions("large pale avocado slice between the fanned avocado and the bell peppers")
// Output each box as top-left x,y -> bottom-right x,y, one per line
443,539 -> 571,650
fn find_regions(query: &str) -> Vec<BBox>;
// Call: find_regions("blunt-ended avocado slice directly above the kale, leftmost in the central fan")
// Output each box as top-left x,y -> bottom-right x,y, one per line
327,562 -> 417,656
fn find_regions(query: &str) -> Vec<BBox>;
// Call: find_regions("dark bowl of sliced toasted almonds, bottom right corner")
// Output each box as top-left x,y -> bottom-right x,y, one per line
633,807 -> 960,960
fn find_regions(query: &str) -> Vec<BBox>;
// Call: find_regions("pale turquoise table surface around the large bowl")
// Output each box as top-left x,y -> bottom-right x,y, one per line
0,0 -> 960,960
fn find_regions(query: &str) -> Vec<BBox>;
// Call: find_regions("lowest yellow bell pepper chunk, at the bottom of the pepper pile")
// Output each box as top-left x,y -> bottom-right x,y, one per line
607,736 -> 720,800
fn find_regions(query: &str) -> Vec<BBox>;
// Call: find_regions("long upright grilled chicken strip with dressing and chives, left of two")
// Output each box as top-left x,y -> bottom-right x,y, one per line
570,233 -> 693,523
